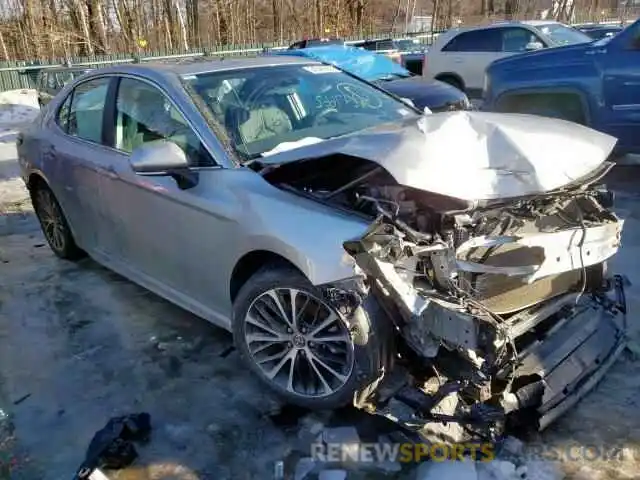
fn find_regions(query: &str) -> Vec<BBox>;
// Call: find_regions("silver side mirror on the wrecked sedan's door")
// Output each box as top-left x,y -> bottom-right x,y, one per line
129,140 -> 198,190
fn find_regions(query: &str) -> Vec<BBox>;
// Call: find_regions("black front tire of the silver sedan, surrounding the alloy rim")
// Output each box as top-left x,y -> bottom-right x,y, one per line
233,265 -> 395,410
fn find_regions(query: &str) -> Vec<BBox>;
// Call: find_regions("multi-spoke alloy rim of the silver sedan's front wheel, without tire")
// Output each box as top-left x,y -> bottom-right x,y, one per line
244,288 -> 354,397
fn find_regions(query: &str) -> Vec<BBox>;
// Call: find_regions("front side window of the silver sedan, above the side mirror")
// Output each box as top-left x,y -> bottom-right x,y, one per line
115,78 -> 215,167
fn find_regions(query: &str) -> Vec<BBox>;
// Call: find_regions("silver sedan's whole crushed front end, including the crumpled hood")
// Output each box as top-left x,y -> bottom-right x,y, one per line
260,112 -> 626,442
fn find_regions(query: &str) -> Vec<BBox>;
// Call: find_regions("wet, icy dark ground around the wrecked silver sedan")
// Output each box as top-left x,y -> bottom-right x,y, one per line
0,95 -> 640,480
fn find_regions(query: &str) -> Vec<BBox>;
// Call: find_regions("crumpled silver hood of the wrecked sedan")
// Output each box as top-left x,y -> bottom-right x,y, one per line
261,111 -> 616,202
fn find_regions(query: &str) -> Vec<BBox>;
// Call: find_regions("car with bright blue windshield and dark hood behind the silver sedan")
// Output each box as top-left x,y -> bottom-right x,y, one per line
276,46 -> 471,112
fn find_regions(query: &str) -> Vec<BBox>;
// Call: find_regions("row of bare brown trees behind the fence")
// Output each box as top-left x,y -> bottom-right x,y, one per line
0,0 -> 640,60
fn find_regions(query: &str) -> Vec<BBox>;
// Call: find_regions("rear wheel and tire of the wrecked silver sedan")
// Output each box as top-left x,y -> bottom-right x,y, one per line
29,182 -> 86,260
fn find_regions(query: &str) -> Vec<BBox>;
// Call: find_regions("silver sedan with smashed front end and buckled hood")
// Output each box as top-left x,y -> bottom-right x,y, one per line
18,57 -> 626,441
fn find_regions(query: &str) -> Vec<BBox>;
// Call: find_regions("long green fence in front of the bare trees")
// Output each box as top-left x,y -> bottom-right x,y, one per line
0,32 -> 434,92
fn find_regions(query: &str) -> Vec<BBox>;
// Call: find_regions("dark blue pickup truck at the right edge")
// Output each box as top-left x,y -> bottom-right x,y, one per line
482,16 -> 640,154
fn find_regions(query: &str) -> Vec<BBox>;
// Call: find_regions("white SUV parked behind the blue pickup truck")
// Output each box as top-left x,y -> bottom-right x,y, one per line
422,20 -> 591,98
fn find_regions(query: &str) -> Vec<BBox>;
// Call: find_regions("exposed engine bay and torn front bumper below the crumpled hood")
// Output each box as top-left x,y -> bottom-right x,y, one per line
261,155 -> 626,442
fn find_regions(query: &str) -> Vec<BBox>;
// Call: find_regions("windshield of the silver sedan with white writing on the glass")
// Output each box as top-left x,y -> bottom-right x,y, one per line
184,64 -> 418,159
